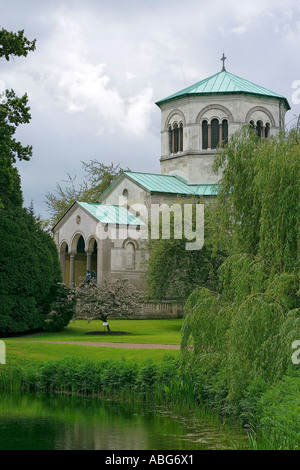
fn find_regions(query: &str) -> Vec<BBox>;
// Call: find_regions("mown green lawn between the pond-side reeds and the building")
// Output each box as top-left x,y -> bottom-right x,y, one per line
2,319 -> 182,367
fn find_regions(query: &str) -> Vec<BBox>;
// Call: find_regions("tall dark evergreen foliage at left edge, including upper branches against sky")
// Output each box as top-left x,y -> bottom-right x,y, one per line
0,29 -> 73,336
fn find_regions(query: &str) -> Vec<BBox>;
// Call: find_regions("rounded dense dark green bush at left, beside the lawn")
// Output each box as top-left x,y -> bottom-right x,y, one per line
0,207 -> 61,336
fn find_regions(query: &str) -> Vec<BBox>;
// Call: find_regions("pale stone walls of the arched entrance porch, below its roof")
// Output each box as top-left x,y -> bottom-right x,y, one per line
54,203 -> 144,290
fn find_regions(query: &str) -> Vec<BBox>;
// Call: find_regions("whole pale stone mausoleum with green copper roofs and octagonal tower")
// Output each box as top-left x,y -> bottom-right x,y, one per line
53,55 -> 290,289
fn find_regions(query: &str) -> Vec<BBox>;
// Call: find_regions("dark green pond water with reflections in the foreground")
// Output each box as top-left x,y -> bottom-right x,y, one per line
0,392 -> 245,450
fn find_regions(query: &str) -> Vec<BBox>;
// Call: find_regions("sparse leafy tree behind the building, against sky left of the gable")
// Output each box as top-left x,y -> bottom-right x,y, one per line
46,160 -> 123,225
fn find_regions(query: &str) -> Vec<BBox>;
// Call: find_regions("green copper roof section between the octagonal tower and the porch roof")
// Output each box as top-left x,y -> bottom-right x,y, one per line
124,171 -> 217,196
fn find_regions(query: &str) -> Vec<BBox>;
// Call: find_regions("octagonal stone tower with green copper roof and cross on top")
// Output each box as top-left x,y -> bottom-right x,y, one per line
156,63 -> 290,184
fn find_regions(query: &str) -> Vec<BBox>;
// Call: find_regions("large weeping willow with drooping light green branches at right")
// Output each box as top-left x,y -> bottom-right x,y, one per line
182,128 -> 300,409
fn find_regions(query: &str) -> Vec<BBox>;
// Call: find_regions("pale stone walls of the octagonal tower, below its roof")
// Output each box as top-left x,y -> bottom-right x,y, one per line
159,94 -> 287,184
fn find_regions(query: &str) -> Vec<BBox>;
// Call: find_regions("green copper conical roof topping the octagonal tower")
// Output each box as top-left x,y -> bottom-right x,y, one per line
156,70 -> 291,109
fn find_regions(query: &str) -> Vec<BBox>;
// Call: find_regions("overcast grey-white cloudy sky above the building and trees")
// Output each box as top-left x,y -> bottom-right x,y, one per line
0,0 -> 300,217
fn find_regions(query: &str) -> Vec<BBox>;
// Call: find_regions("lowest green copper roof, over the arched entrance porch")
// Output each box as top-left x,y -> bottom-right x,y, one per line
77,201 -> 145,225
